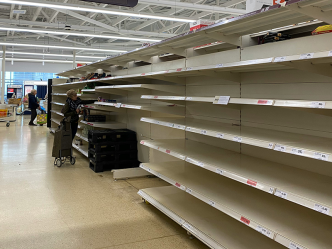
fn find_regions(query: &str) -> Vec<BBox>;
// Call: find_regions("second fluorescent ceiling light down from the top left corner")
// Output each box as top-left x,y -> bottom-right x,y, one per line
0,27 -> 161,42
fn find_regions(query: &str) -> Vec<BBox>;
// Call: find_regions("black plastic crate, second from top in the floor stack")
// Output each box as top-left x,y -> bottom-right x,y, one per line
89,142 -> 137,153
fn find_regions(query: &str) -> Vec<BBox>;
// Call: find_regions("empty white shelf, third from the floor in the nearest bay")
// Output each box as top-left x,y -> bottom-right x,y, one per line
141,139 -> 332,216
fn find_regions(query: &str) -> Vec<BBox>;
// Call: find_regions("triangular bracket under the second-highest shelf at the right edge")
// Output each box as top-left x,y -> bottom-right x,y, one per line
281,61 -> 332,77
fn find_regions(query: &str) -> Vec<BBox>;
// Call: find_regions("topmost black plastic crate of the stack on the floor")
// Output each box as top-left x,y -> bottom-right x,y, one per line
88,129 -> 137,144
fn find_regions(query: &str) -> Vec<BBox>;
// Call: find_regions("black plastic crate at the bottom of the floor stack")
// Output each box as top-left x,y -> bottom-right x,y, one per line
89,159 -> 140,173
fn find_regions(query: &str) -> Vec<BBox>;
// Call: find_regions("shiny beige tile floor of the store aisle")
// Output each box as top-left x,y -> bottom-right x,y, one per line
0,118 -> 207,249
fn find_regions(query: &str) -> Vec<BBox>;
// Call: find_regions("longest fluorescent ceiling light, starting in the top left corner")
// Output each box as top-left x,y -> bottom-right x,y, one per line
0,0 -> 196,23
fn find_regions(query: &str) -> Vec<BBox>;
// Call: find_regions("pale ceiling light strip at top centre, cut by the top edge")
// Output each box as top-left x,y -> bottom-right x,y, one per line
140,0 -> 246,15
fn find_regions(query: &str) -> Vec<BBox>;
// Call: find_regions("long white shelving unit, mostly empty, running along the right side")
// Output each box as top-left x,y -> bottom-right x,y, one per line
54,0 -> 332,249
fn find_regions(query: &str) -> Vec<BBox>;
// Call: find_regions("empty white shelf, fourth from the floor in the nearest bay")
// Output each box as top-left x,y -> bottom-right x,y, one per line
141,118 -> 332,162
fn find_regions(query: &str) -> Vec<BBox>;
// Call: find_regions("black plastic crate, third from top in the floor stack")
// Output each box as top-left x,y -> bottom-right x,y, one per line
89,149 -> 137,162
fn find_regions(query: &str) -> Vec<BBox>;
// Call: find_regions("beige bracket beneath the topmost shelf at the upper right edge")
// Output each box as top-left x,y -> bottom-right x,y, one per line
286,4 -> 332,24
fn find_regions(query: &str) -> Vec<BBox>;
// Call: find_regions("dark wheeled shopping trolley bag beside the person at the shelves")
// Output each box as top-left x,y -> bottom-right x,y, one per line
52,118 -> 76,167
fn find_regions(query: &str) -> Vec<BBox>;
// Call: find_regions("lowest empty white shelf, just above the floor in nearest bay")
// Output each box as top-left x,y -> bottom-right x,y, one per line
138,186 -> 283,249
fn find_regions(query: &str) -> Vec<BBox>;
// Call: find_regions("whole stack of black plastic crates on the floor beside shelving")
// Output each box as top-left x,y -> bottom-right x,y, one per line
88,129 -> 139,173
